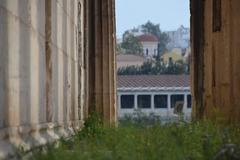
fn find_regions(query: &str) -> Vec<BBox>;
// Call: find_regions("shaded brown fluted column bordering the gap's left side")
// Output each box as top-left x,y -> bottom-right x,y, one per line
86,0 -> 116,124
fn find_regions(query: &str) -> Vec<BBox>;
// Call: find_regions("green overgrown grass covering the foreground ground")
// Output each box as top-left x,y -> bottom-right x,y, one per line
26,113 -> 240,160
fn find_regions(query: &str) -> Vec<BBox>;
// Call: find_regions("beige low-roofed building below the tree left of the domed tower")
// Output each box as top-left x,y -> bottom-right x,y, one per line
117,54 -> 144,69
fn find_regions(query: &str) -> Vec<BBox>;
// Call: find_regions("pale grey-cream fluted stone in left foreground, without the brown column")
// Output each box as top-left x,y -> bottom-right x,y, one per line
0,0 -> 86,159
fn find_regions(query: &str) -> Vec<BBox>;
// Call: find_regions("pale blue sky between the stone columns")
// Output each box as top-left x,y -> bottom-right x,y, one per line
116,0 -> 190,38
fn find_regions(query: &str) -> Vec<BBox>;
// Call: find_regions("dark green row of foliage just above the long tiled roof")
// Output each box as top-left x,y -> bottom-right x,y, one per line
117,61 -> 189,75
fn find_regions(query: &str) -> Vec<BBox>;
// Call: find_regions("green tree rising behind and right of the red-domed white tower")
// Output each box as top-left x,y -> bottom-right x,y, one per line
142,21 -> 170,54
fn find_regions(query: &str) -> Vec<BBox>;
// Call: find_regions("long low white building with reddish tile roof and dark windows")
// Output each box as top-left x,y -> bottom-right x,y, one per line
117,75 -> 192,119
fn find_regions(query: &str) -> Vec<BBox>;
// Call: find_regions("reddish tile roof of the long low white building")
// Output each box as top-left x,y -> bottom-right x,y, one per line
117,75 -> 190,88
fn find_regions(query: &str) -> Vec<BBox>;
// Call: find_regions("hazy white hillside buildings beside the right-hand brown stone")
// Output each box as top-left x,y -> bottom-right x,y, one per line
166,26 -> 190,49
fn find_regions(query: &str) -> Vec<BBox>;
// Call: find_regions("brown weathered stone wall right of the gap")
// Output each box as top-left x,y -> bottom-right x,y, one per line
191,0 -> 240,123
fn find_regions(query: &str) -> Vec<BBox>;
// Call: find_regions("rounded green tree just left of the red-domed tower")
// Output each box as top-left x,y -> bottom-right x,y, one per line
121,32 -> 143,55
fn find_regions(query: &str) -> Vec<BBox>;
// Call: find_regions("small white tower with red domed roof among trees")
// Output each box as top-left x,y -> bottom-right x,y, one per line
138,34 -> 159,57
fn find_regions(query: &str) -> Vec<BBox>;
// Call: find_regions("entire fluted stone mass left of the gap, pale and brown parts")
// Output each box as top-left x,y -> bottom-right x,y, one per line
0,0 -> 116,159
